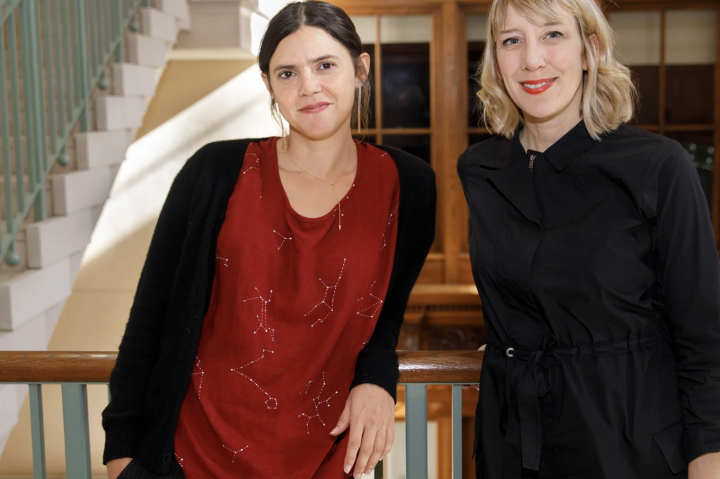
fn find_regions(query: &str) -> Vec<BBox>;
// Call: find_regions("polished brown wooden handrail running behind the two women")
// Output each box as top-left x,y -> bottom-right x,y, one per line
0,351 -> 483,384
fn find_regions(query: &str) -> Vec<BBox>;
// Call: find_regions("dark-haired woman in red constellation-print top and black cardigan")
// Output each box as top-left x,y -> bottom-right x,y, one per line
103,2 -> 436,479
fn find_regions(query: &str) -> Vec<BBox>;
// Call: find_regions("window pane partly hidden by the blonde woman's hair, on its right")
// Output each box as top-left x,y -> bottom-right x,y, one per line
610,12 -> 660,125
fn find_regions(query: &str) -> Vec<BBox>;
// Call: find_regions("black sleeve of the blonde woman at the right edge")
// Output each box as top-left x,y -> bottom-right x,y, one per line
643,141 -> 720,461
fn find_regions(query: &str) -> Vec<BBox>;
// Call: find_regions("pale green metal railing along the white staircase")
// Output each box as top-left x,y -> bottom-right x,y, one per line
0,0 -> 150,265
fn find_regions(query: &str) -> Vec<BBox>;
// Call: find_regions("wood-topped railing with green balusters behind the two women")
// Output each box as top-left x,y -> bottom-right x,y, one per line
0,351 -> 483,479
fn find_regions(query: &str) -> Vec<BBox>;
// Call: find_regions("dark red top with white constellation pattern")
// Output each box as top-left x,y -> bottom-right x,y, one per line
175,138 -> 400,479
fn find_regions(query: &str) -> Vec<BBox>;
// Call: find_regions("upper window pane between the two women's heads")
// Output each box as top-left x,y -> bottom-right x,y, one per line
380,15 -> 432,128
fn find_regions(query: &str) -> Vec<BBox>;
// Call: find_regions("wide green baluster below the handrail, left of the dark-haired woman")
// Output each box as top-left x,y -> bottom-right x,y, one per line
62,383 -> 92,479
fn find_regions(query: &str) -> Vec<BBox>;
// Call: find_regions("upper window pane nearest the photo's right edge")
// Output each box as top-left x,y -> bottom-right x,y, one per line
665,11 -> 716,124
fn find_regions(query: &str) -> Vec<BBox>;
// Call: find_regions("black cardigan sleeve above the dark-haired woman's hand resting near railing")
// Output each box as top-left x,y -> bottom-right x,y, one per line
351,157 -> 437,400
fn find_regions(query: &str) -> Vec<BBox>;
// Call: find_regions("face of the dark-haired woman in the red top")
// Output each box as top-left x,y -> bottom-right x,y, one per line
263,26 -> 369,140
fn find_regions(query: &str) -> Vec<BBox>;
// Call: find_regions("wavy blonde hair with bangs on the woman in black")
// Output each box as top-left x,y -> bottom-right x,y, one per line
476,0 -> 637,140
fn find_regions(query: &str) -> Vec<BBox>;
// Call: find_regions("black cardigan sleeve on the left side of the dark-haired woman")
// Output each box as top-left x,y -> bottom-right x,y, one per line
102,153 -> 202,463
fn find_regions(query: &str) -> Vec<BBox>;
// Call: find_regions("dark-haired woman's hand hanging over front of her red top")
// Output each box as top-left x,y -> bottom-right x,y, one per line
330,384 -> 395,479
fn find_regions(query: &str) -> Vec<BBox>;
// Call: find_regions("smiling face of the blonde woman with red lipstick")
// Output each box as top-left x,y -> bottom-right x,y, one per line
496,7 -> 587,123
